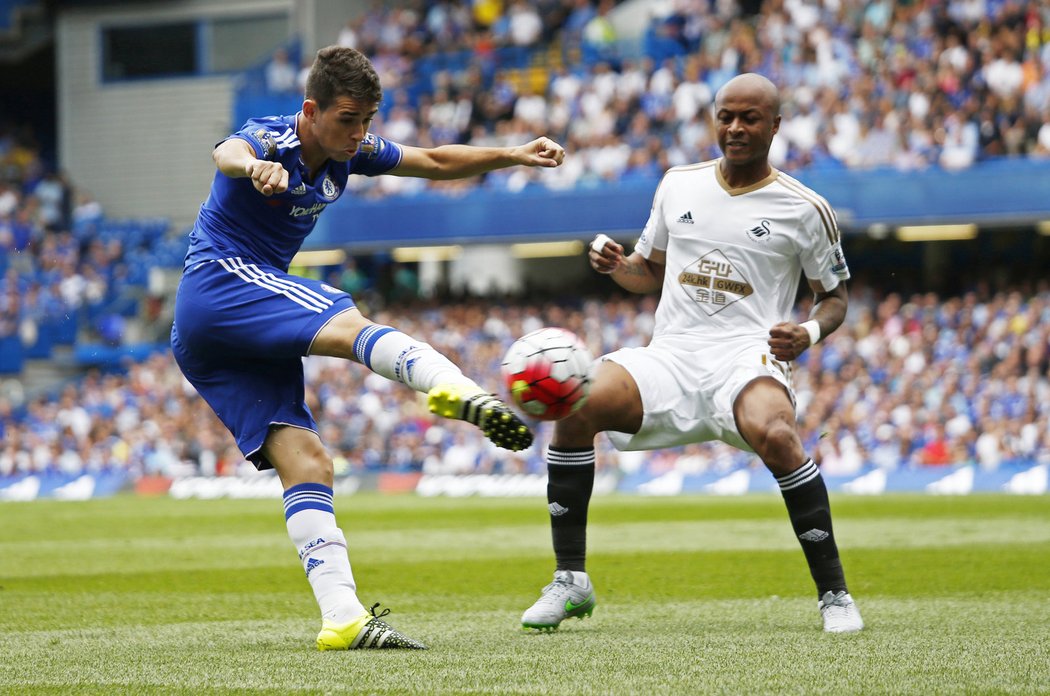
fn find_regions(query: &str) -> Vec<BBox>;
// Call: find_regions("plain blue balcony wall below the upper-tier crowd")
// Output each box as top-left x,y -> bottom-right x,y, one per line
305,159 -> 1050,249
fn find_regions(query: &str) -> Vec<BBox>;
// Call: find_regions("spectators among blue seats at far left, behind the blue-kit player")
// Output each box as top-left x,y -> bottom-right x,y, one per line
0,125 -> 186,365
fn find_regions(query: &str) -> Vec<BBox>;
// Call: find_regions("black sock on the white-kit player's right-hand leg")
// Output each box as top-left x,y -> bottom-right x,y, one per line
777,459 -> 846,597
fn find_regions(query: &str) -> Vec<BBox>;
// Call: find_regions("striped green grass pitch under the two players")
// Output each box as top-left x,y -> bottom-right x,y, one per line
0,494 -> 1050,695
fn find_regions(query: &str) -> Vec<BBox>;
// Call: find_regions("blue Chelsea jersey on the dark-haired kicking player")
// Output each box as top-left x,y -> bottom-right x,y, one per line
186,114 -> 402,270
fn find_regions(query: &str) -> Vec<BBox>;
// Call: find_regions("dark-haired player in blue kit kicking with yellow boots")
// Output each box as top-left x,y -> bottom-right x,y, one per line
171,46 -> 565,650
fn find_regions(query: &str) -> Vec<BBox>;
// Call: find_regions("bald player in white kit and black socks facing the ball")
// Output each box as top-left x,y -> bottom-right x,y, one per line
522,73 -> 863,633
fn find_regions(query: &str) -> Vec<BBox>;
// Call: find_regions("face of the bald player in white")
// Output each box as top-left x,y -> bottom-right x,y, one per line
715,88 -> 780,166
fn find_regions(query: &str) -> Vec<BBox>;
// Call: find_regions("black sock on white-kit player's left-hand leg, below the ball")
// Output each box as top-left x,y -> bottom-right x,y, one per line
547,447 -> 594,571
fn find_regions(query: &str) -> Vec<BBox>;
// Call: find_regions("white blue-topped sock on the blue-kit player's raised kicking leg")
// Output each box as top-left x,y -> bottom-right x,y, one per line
354,323 -> 481,393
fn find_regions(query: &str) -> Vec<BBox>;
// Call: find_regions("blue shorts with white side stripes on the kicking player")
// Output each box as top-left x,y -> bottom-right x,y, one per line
171,258 -> 354,469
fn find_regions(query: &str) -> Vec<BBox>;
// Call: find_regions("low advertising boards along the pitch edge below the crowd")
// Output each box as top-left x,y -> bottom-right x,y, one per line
0,463 -> 1050,502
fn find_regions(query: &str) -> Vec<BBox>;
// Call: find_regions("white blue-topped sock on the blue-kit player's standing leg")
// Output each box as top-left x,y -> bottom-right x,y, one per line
285,483 -> 365,624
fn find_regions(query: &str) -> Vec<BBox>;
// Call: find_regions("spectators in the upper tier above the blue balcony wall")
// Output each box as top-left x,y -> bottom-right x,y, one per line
291,0 -> 1050,200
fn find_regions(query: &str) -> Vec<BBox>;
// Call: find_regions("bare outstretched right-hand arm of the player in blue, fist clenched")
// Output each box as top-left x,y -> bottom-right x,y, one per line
390,136 -> 565,180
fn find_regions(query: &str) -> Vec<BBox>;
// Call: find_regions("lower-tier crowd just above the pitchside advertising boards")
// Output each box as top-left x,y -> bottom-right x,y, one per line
0,282 -> 1050,477
